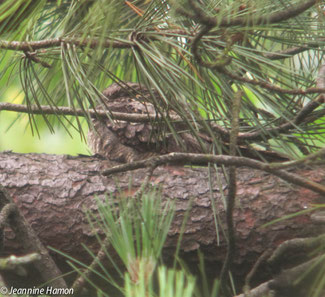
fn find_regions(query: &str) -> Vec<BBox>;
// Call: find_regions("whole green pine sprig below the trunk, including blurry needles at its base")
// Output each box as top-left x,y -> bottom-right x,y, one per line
61,191 -> 206,297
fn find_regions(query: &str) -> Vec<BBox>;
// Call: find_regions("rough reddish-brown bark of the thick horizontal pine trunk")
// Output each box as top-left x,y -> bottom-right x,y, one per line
0,152 -> 325,284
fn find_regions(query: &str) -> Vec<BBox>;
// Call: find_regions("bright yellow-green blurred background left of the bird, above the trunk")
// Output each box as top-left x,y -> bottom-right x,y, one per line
0,82 -> 90,155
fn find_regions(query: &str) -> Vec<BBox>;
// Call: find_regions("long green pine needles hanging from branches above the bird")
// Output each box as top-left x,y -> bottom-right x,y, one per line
0,0 -> 325,156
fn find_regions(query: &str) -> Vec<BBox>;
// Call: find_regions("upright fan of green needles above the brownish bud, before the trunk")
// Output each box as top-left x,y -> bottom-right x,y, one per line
94,192 -> 173,271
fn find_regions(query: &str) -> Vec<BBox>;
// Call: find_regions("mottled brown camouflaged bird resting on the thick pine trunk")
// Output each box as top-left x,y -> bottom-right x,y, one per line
88,83 -> 205,163
